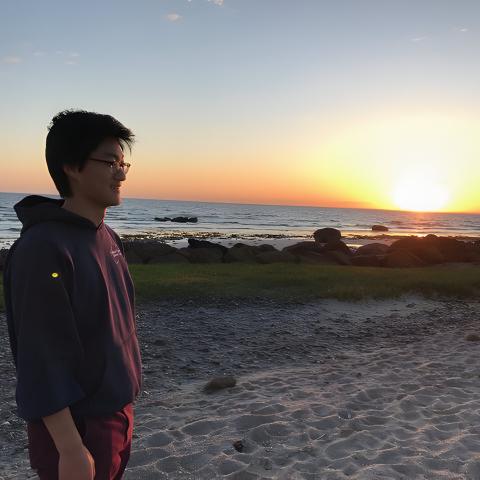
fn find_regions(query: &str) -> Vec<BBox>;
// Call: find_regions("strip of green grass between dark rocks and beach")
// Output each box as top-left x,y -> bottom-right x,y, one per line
0,264 -> 480,311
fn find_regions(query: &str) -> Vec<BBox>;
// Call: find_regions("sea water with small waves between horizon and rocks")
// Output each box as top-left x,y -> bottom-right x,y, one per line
0,192 -> 480,248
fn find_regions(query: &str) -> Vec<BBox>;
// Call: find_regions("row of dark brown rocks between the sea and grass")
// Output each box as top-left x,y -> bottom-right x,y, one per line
124,228 -> 480,267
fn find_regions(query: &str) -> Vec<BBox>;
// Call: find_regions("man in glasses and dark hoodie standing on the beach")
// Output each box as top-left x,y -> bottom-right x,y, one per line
4,111 -> 141,480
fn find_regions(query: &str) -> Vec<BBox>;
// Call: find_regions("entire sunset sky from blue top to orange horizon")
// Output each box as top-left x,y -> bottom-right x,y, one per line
0,0 -> 480,212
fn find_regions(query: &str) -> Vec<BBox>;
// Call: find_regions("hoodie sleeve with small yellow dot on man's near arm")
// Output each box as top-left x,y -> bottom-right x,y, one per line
6,239 -> 85,420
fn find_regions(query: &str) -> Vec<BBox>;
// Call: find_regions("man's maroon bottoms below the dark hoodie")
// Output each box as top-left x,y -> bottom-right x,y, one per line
27,403 -> 133,480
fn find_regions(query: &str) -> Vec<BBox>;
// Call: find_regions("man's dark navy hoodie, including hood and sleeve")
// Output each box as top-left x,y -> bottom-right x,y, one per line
3,195 -> 141,420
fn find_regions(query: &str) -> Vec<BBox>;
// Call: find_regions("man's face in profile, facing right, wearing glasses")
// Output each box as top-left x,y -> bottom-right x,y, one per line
64,138 -> 126,208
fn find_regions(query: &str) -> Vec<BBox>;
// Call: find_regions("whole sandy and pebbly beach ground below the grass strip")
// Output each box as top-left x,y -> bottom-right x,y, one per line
0,297 -> 480,480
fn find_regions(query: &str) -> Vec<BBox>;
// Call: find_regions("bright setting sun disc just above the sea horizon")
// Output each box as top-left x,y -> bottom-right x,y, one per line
393,176 -> 449,212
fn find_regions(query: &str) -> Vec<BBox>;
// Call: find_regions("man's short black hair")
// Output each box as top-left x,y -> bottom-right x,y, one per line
45,110 -> 135,198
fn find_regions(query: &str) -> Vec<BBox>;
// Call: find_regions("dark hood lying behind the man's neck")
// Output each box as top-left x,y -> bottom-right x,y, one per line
13,195 -> 103,235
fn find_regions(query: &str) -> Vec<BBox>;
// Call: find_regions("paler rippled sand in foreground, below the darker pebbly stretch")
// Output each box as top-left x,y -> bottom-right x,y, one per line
126,314 -> 480,480
